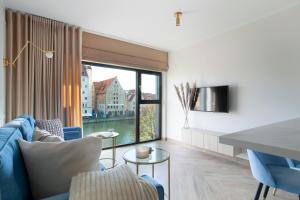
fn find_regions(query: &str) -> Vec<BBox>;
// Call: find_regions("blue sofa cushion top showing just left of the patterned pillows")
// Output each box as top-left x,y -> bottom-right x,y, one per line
4,118 -> 34,142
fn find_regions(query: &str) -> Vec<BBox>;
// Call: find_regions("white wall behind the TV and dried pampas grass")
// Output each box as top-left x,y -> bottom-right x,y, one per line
167,6 -> 300,140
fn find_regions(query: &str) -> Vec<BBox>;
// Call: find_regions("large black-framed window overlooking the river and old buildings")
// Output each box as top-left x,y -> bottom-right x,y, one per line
81,62 -> 162,148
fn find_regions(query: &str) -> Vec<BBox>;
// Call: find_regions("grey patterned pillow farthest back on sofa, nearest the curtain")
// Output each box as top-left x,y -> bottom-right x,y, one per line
36,119 -> 64,138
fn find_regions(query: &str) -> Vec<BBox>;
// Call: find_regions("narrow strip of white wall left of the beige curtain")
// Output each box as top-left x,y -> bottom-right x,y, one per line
0,0 -> 5,126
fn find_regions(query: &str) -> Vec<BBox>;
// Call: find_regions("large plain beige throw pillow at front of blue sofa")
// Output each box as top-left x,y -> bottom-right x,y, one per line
18,137 -> 101,199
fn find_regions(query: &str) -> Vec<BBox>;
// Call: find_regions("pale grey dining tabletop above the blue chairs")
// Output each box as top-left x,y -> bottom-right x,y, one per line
219,118 -> 300,160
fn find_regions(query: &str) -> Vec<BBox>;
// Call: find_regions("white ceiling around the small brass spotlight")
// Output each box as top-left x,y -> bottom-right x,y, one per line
4,0 -> 300,51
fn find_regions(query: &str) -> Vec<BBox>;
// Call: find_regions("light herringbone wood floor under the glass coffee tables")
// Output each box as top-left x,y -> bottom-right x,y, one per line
102,141 -> 298,200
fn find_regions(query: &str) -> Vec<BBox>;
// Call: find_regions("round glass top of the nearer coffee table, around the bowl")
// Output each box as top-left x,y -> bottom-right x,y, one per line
123,147 -> 170,165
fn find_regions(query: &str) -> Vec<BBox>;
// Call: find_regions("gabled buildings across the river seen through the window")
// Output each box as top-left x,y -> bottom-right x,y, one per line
81,65 -> 154,119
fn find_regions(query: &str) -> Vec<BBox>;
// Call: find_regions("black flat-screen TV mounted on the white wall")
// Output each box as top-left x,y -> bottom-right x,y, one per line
191,86 -> 229,112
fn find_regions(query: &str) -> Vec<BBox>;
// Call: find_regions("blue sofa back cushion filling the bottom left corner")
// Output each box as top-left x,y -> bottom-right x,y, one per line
0,128 -> 31,200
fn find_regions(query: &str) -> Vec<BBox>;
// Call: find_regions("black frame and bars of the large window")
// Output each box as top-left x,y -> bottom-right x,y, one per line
82,61 -> 163,149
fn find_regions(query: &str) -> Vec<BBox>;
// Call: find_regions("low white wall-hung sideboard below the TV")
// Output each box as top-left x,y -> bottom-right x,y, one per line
181,128 -> 243,157
